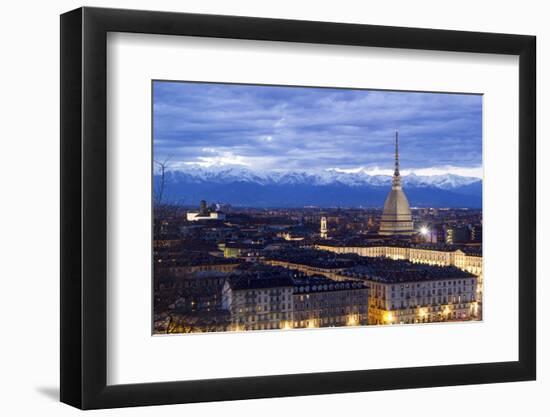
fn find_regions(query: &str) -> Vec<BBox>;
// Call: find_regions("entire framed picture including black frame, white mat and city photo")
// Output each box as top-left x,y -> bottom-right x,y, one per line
60,7 -> 536,409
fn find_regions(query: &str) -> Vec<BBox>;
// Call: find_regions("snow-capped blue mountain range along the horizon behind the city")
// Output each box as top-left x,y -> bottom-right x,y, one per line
155,166 -> 482,208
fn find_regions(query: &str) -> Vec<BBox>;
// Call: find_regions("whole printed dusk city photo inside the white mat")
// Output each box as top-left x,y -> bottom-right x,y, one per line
153,82 -> 483,334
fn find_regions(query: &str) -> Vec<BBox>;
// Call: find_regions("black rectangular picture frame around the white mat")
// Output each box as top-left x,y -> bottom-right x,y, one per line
60,7 -> 536,409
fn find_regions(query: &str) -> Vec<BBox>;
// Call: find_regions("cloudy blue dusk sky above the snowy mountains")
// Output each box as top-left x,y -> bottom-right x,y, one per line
153,81 -> 482,178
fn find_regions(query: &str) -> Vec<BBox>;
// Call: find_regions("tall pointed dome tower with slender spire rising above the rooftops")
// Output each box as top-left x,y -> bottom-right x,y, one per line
379,132 -> 414,236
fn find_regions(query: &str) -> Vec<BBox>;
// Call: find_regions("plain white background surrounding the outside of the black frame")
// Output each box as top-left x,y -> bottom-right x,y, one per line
0,0 -> 550,417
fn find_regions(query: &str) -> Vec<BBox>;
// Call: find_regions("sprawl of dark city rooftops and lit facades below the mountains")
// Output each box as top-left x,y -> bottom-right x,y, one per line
153,187 -> 483,333
